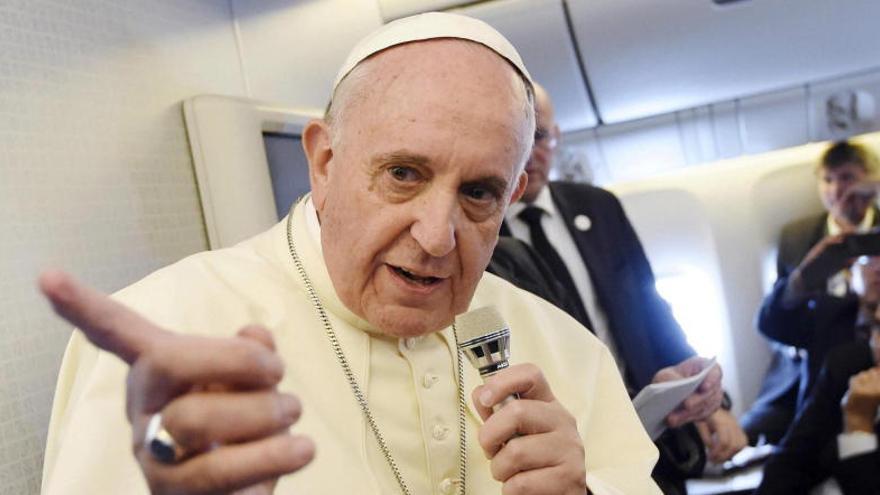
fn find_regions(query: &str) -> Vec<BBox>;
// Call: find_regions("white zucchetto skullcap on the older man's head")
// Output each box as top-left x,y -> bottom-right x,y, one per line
333,12 -> 532,92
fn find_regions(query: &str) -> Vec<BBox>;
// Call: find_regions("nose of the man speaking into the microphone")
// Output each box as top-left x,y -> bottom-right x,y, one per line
410,194 -> 460,257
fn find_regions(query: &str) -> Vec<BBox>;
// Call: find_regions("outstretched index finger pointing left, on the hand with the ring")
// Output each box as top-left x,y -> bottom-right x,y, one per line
39,271 -> 170,364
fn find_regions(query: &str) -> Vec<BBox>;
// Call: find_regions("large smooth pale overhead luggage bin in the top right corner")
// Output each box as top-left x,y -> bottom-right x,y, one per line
567,0 -> 880,123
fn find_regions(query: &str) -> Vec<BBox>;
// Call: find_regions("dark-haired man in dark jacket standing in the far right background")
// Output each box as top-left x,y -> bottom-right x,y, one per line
742,142 -> 880,443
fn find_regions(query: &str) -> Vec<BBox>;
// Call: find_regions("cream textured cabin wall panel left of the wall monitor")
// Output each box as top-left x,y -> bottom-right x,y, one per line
0,0 -> 244,494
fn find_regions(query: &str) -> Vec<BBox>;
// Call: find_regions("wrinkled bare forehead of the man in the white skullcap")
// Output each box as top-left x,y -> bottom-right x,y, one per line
341,39 -> 534,161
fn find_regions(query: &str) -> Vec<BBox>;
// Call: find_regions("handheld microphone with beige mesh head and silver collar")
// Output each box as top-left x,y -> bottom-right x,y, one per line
455,306 -> 519,411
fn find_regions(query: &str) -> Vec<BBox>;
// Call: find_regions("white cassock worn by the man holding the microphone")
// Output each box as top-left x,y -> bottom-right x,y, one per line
43,199 -> 660,495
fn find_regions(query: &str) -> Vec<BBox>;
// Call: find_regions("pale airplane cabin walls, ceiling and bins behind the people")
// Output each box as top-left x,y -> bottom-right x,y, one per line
0,0 -> 880,495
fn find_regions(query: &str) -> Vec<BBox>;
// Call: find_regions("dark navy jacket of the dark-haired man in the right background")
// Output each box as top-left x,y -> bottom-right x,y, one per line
745,211 -> 878,440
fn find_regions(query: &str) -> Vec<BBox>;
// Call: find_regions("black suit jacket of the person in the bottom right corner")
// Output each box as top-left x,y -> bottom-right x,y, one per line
756,341 -> 880,495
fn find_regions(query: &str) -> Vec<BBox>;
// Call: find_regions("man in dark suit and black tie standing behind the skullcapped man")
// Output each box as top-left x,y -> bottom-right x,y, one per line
492,86 -> 745,493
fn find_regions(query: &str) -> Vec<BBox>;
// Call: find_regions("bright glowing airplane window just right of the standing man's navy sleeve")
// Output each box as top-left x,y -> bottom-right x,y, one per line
656,267 -> 724,357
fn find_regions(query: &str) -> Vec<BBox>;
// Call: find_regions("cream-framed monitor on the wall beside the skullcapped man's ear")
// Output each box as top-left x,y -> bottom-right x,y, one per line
183,95 -> 320,249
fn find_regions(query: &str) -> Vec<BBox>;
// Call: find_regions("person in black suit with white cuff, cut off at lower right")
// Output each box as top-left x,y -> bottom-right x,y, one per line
758,257 -> 880,495
